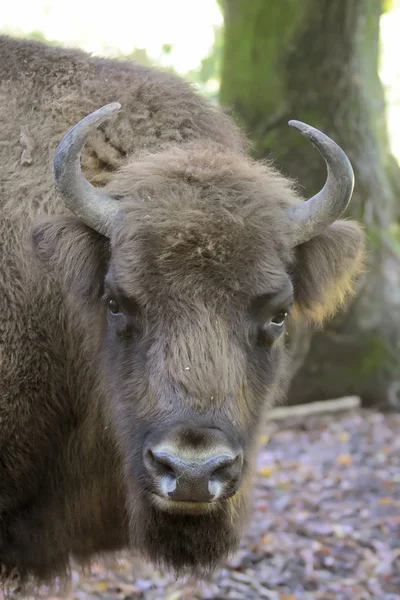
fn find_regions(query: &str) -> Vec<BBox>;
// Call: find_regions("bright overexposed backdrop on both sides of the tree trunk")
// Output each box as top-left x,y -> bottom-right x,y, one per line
0,0 -> 400,160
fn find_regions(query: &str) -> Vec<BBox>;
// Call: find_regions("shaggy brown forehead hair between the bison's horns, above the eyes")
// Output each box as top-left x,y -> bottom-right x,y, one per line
108,143 -> 293,298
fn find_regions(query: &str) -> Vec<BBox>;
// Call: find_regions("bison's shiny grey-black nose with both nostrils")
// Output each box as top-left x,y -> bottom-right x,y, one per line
145,447 -> 243,502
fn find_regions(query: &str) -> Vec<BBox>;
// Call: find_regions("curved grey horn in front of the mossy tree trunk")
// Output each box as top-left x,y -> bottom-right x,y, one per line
288,121 -> 354,246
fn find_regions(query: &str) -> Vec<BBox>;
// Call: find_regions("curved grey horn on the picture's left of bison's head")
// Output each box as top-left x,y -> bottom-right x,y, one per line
53,102 -> 121,237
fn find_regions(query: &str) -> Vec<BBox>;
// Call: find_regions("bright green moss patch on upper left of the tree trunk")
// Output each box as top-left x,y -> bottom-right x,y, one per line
220,0 -> 309,130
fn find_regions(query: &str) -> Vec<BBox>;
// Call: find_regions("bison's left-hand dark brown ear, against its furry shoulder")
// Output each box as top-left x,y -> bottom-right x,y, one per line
31,217 -> 109,303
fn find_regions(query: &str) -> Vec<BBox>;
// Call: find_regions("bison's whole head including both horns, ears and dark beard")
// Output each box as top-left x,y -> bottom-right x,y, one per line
34,104 -> 362,571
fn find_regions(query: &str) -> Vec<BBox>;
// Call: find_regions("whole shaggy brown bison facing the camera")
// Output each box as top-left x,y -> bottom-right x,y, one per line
0,36 -> 363,586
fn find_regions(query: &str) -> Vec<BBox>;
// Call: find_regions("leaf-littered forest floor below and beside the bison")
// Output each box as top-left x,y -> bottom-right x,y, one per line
13,409 -> 400,600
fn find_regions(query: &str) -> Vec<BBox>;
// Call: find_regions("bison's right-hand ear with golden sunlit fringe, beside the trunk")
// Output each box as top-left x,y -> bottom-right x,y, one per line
293,221 -> 365,324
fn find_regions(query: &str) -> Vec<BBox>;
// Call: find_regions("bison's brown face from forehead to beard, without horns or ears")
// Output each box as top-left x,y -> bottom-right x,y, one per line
95,202 -> 293,569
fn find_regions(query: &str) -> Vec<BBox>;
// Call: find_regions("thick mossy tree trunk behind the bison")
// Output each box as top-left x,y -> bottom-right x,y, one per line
220,0 -> 400,409
